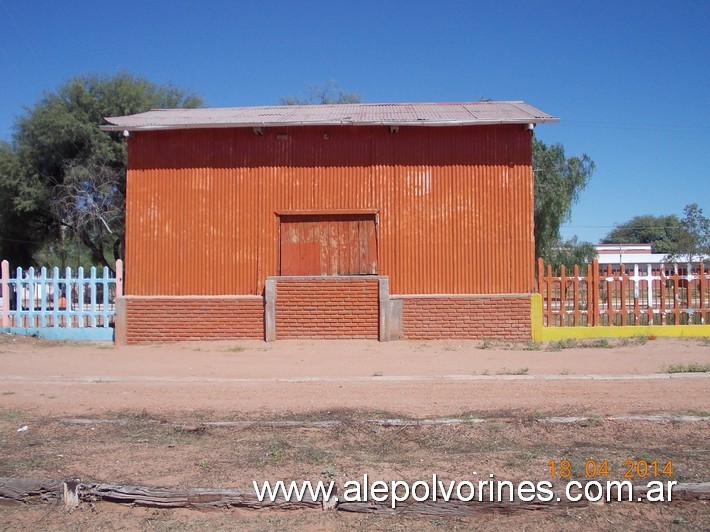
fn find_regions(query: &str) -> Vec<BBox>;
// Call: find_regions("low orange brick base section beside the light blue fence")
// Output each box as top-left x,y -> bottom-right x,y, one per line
122,296 -> 264,344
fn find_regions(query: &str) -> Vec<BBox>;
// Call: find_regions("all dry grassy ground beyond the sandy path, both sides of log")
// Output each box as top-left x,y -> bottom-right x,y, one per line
0,410 -> 710,530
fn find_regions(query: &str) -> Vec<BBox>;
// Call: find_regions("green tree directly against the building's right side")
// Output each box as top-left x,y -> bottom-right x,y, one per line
533,137 -> 595,262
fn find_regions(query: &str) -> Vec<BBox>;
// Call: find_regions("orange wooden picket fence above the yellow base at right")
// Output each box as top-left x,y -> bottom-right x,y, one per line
537,259 -> 710,327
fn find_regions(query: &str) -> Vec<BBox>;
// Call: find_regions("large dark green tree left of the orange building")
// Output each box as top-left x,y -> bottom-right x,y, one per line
0,72 -> 202,267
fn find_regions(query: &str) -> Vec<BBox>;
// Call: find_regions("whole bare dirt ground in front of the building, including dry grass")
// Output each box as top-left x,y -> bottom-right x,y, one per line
0,336 -> 710,530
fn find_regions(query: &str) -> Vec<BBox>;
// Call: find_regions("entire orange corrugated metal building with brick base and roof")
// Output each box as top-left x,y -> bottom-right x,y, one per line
102,102 -> 557,342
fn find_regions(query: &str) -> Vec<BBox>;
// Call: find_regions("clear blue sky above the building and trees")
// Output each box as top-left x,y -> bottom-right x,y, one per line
0,0 -> 710,242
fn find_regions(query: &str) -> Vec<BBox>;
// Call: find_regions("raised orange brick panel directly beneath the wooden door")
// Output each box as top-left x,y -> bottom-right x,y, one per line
275,277 -> 379,339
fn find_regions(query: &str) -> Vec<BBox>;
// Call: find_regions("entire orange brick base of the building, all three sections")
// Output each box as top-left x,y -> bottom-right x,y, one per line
116,284 -> 532,344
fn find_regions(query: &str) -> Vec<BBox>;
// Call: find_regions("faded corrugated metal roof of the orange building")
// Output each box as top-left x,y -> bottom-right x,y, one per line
101,102 -> 559,131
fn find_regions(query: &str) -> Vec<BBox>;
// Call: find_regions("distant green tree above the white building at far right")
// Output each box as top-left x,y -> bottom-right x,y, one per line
602,214 -> 683,254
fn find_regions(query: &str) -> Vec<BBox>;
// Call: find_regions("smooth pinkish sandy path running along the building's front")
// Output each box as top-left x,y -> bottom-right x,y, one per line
0,337 -> 710,418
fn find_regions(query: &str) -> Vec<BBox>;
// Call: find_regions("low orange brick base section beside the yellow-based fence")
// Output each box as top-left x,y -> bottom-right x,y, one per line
396,294 -> 532,341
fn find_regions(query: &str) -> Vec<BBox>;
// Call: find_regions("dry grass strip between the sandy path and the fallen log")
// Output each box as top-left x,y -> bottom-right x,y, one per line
0,411 -> 710,487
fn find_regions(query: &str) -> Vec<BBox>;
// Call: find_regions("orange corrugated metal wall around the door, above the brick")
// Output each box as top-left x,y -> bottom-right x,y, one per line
125,125 -> 535,295
